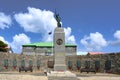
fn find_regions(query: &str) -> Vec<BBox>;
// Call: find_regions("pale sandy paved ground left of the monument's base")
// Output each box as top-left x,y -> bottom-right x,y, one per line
0,72 -> 48,80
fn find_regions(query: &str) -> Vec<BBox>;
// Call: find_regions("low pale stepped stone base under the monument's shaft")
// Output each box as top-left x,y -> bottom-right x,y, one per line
47,71 -> 79,80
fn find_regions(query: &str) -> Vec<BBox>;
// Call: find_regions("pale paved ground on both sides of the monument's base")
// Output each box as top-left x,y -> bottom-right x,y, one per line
0,72 -> 120,80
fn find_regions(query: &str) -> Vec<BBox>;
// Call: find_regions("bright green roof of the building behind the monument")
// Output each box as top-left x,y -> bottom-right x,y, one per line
22,42 -> 77,47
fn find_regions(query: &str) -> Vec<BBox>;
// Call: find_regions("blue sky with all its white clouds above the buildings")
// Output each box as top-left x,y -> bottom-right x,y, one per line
0,0 -> 120,54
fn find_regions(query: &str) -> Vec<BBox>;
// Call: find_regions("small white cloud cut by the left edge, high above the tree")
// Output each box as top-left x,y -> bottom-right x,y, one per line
0,12 -> 12,29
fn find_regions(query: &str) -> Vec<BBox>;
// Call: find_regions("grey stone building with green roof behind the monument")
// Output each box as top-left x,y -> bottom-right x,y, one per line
22,42 -> 77,55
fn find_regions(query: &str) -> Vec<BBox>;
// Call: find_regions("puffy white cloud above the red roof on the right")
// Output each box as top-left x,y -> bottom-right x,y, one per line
80,32 -> 107,51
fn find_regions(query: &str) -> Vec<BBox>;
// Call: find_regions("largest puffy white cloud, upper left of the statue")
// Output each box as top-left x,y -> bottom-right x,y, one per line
14,7 -> 57,33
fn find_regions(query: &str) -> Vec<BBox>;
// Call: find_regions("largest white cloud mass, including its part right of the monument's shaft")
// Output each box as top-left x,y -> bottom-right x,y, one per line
14,7 -> 75,43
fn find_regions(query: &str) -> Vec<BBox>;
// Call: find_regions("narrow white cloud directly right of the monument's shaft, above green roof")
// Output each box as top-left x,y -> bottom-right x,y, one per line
64,27 -> 76,44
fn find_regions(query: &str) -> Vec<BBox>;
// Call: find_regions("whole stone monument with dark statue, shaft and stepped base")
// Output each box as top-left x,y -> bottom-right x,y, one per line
47,14 -> 78,80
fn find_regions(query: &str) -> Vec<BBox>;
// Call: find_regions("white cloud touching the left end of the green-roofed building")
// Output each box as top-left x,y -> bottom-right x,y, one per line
10,33 -> 30,53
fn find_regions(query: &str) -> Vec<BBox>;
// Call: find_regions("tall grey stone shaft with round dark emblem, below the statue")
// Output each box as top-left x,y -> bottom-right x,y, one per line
54,27 -> 66,71
